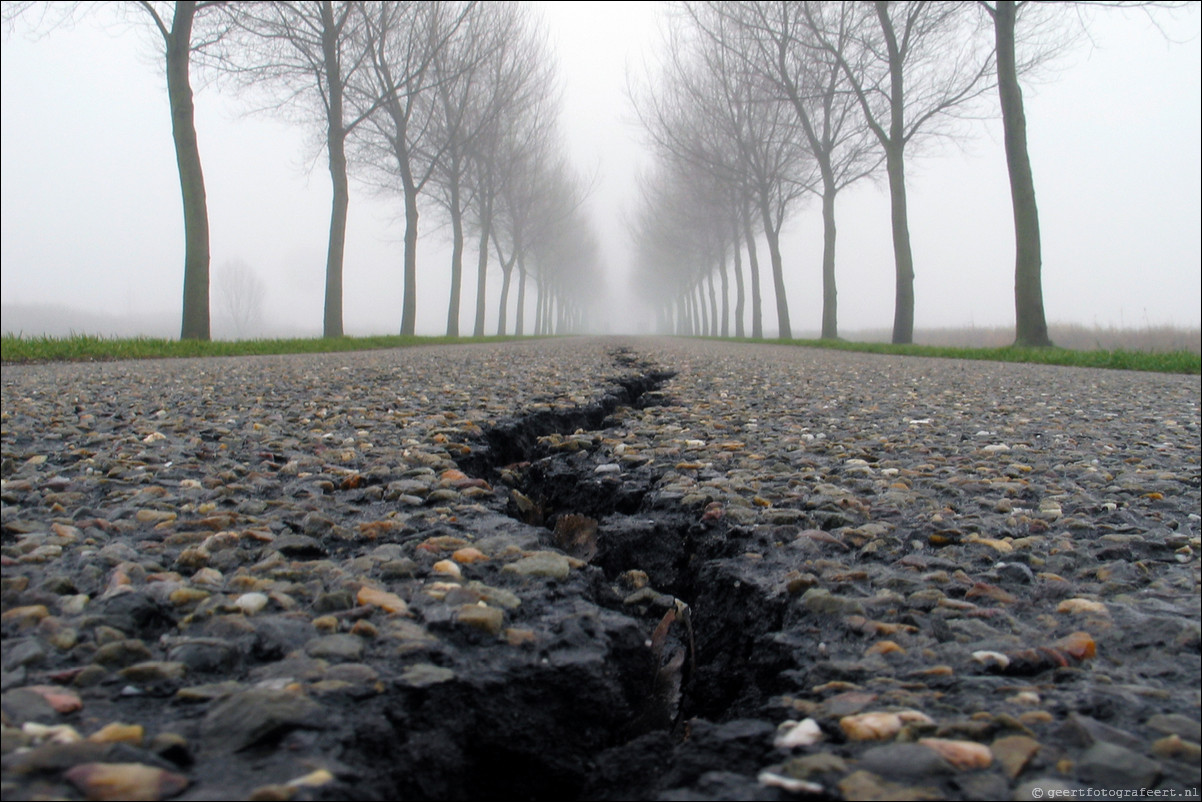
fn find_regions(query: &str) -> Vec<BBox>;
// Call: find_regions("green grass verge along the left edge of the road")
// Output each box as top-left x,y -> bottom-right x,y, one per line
0,334 -> 518,364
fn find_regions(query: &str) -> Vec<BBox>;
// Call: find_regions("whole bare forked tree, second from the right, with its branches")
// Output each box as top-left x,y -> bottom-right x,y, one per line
801,0 -> 993,343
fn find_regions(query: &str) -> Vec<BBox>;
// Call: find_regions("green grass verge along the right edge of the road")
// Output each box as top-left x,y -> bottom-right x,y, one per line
706,338 -> 1202,375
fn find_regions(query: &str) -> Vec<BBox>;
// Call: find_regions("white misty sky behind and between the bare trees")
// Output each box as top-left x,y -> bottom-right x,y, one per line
0,1 -> 1202,334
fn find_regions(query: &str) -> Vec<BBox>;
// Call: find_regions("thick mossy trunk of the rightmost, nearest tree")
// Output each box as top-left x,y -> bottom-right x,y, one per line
993,0 -> 1052,347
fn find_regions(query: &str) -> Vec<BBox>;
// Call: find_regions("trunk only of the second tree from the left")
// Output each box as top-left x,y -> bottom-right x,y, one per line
321,0 -> 351,337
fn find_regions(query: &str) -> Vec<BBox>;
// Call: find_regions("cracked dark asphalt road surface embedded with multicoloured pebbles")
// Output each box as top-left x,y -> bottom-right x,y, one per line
0,338 -> 1202,800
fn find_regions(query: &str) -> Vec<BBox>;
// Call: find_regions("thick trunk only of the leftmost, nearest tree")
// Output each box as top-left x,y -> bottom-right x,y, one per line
166,2 -> 209,340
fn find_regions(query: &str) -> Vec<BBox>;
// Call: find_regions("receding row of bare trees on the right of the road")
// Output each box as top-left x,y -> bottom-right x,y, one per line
633,0 -> 1120,346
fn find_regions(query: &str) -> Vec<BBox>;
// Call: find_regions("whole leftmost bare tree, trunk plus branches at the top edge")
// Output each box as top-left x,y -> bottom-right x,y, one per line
4,0 -> 227,340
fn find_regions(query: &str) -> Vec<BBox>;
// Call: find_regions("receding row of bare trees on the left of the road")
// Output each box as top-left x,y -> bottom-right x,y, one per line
5,0 -> 597,339
